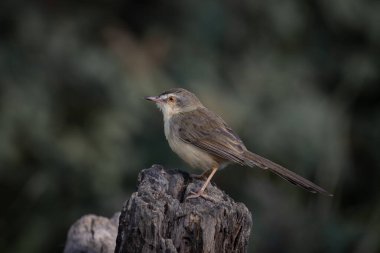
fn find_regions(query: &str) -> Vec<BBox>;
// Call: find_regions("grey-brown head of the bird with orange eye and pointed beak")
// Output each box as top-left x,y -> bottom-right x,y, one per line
145,88 -> 203,118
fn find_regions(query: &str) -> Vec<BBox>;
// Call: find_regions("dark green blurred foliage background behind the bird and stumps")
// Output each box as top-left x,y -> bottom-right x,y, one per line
0,0 -> 380,253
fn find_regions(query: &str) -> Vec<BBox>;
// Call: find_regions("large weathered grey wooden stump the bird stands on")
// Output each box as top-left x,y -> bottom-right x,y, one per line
115,165 -> 252,253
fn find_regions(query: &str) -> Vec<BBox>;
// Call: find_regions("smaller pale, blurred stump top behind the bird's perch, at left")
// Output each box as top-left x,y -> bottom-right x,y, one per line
64,213 -> 120,253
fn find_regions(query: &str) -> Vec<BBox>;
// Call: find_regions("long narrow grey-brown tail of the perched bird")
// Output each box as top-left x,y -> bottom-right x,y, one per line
244,151 -> 333,197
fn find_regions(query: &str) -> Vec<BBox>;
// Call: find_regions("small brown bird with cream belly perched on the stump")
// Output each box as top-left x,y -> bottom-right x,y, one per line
145,88 -> 333,199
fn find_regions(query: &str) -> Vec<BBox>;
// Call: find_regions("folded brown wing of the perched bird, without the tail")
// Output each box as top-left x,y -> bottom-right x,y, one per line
171,108 -> 246,165
